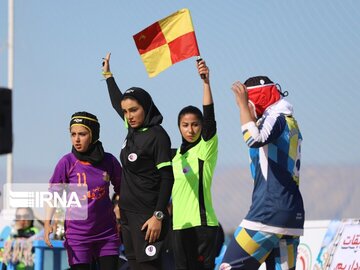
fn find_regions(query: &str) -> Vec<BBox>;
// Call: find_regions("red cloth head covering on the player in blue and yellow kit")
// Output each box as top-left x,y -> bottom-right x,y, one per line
247,83 -> 280,118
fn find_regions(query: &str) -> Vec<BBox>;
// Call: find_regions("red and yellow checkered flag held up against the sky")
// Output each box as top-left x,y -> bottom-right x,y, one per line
133,9 -> 200,77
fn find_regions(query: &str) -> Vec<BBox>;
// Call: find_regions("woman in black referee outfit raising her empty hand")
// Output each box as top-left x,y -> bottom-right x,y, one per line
103,53 -> 174,270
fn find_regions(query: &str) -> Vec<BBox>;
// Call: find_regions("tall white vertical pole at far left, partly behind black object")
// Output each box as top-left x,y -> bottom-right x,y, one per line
6,0 -> 14,184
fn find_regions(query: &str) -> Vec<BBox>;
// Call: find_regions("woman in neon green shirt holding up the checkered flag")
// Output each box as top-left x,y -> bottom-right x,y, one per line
172,60 -> 219,270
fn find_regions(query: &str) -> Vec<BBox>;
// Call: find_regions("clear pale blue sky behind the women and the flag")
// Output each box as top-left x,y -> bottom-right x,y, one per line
0,0 -> 360,183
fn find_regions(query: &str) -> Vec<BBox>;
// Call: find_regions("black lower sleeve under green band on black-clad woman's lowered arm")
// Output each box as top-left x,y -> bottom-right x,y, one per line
155,166 -> 174,211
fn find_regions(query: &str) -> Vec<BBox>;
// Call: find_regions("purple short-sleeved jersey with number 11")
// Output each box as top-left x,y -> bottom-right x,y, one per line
50,153 -> 122,243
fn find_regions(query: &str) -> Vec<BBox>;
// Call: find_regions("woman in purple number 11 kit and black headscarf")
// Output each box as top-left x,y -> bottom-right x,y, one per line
44,112 -> 122,270
